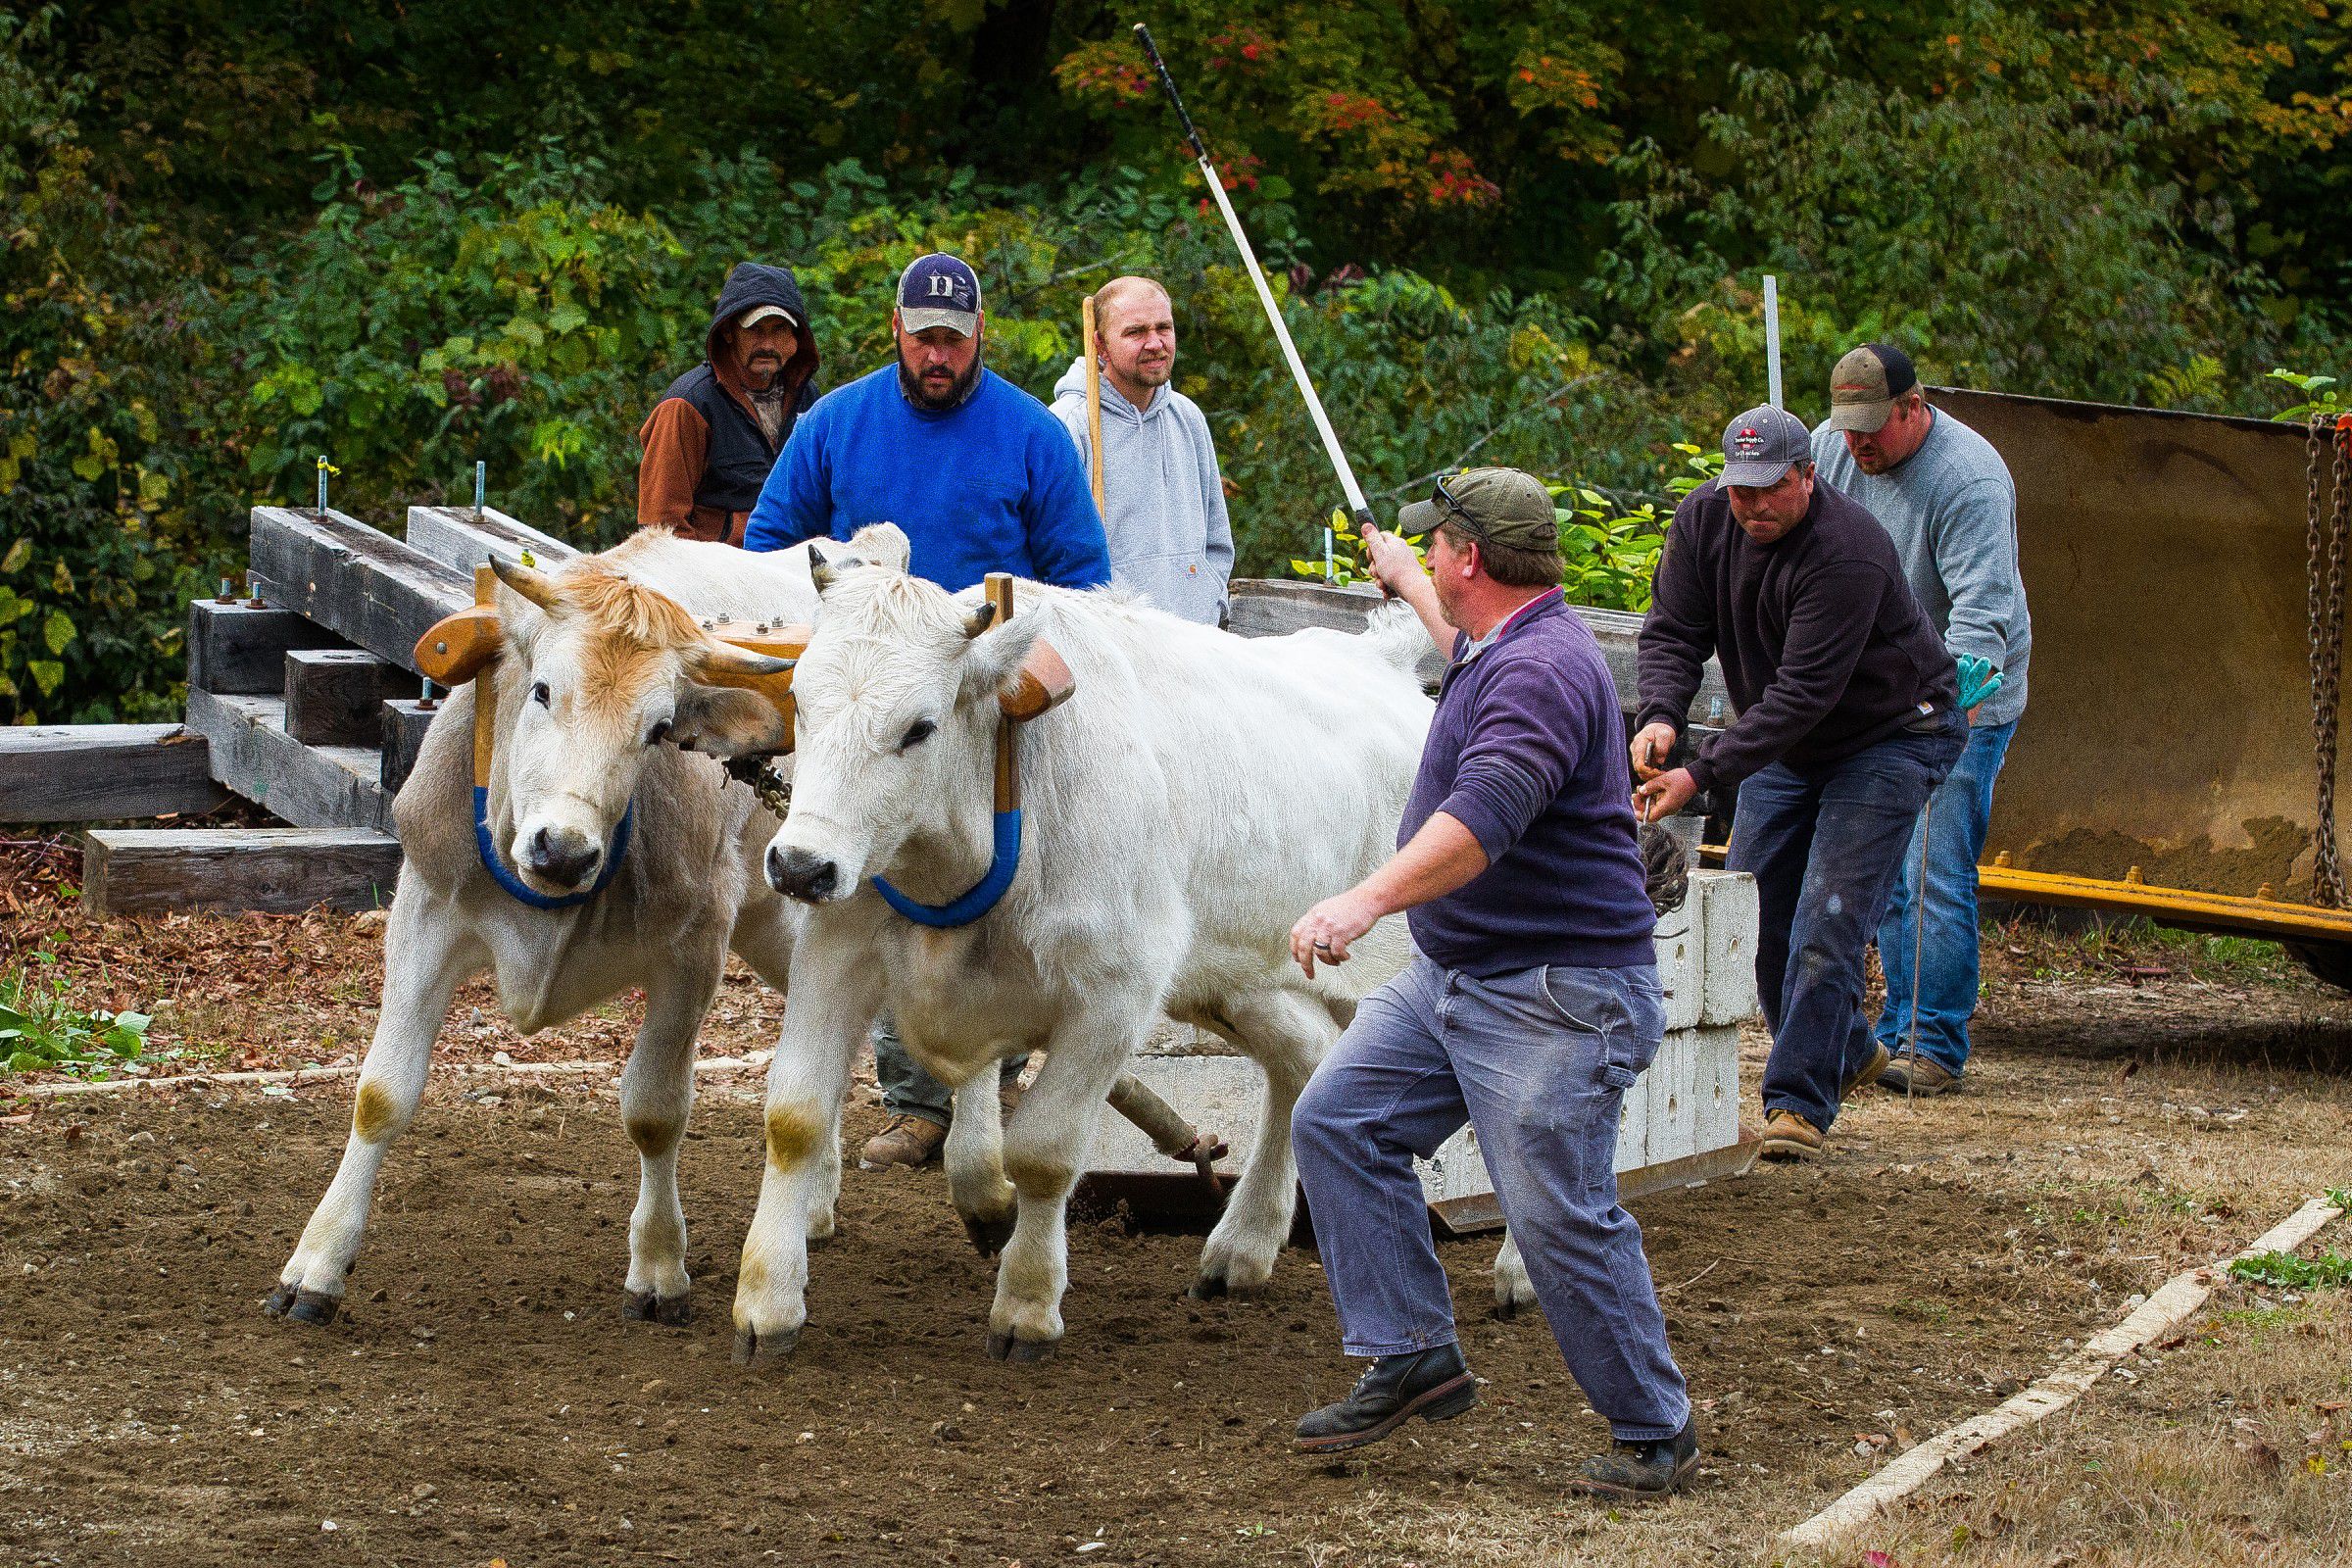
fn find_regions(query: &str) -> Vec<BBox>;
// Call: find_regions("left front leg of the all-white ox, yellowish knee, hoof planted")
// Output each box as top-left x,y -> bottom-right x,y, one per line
734,948 -> 875,1366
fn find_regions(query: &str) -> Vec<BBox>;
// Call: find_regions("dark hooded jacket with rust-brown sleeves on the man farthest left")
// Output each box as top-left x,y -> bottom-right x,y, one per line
637,261 -> 816,546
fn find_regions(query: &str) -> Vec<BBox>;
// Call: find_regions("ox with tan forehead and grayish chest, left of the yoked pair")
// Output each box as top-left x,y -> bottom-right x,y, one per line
269,526 -> 906,1324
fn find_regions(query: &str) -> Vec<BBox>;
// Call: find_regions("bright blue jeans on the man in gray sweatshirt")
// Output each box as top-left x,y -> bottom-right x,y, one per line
1880,719 -> 2018,1077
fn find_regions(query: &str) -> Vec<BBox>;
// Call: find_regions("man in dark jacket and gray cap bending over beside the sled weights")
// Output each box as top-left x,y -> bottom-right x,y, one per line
1633,407 -> 1969,1159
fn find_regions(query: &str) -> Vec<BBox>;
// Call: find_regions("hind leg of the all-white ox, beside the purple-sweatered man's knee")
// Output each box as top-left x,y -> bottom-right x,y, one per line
1188,992 -> 1339,1300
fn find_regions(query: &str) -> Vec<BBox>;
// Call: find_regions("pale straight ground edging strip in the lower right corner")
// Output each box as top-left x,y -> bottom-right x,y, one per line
1781,1199 -> 2345,1546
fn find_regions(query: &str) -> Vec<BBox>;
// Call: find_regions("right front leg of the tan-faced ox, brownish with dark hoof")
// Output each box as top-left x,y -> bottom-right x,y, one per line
621,955 -> 719,1326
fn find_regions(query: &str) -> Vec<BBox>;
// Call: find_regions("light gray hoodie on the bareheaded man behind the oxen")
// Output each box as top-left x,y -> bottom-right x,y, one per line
1054,358 -> 1233,625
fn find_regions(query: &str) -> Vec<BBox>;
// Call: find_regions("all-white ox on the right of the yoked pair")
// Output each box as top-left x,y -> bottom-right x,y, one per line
734,566 -> 1430,1363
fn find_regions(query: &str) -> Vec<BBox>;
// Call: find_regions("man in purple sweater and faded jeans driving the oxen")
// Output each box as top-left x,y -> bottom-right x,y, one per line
1292,467 -> 1698,1497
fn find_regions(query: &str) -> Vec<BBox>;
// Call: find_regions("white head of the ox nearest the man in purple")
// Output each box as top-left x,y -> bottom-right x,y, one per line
764,569 -> 1058,906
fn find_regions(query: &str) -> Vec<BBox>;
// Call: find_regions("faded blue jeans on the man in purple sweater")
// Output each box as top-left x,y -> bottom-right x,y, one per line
1292,956 -> 1691,1441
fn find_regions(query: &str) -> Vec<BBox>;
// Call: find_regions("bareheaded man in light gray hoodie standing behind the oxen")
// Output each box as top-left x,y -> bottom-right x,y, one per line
1054,277 -> 1233,625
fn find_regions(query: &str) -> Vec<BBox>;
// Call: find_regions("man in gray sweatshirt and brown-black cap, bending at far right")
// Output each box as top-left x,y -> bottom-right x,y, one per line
1813,343 -> 2034,1096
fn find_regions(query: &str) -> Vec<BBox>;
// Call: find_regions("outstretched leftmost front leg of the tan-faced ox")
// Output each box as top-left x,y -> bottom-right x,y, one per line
264,877 -> 489,1324
